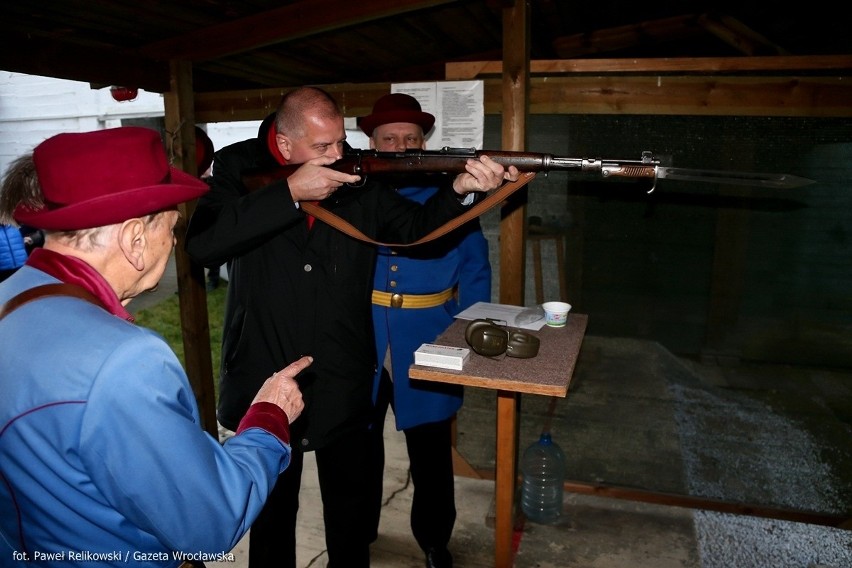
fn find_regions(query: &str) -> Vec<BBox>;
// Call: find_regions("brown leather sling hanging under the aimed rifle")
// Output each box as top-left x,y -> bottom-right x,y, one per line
300,172 -> 535,247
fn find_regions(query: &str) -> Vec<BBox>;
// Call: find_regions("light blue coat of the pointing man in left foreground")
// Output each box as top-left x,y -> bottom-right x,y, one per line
0,266 -> 290,568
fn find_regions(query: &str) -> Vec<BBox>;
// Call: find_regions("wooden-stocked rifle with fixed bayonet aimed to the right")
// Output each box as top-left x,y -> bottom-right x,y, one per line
242,147 -> 814,193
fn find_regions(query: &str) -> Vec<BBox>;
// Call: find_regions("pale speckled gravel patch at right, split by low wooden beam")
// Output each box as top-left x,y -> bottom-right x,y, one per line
672,360 -> 852,568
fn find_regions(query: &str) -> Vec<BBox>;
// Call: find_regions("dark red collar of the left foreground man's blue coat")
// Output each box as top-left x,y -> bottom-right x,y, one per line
27,248 -> 136,322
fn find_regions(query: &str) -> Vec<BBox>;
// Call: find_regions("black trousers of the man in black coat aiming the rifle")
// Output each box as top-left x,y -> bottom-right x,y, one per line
249,429 -> 370,568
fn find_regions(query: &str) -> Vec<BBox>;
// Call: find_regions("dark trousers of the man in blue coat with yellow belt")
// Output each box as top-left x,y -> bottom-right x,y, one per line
368,370 -> 456,551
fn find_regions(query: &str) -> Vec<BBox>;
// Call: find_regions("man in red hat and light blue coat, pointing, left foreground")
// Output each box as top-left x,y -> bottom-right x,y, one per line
0,127 -> 311,566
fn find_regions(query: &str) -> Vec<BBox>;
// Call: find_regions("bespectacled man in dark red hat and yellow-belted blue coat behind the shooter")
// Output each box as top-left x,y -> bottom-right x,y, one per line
358,93 -> 491,568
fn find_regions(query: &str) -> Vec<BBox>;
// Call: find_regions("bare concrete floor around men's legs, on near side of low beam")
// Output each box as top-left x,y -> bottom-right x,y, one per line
208,412 -> 700,568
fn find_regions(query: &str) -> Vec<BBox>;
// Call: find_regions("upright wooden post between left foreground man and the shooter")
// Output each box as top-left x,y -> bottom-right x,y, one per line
164,61 -> 218,439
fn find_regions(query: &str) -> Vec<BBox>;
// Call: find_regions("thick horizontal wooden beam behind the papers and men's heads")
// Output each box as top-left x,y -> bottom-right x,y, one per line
195,75 -> 852,122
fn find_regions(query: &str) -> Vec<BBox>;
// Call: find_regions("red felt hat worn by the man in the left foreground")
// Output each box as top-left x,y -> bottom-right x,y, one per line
14,126 -> 209,231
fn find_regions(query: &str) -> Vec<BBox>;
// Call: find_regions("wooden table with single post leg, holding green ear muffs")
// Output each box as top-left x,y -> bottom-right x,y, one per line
408,313 -> 588,568
